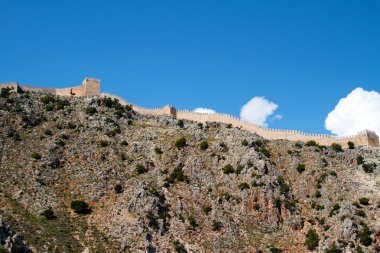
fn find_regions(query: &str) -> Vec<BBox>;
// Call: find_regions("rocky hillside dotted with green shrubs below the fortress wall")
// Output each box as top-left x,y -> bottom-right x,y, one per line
0,89 -> 380,253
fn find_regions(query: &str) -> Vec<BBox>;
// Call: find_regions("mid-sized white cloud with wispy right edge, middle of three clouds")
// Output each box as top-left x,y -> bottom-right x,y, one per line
240,97 -> 282,127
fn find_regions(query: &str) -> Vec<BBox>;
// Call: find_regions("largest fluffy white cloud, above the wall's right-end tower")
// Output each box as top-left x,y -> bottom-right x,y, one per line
325,88 -> 380,136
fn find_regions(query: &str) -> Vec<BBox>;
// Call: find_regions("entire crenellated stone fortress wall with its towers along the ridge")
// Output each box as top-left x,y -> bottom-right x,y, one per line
0,78 -> 380,147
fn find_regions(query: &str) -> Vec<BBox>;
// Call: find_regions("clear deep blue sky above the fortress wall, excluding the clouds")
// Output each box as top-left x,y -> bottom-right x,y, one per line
0,0 -> 380,133
